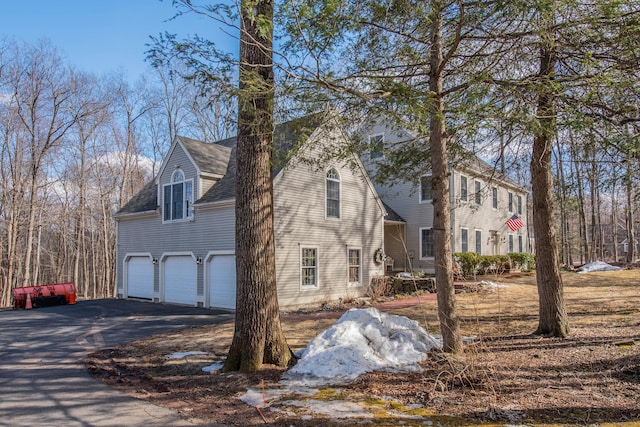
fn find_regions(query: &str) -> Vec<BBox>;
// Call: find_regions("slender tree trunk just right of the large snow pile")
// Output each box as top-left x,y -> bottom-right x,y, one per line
429,1 -> 462,353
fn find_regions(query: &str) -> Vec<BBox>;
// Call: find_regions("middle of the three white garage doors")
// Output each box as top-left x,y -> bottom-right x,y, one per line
163,255 -> 196,305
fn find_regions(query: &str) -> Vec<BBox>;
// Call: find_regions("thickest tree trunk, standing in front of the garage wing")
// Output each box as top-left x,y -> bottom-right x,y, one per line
223,0 -> 294,372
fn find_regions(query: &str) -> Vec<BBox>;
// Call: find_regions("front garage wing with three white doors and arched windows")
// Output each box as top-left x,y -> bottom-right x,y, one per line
116,116 -> 386,309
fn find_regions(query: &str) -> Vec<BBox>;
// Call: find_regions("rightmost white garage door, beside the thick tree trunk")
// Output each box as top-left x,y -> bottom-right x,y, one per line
208,255 -> 236,310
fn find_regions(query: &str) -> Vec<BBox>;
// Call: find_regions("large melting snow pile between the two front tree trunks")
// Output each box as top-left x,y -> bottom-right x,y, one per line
283,308 -> 441,386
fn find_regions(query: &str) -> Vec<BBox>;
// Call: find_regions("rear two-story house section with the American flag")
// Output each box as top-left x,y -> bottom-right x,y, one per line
362,122 -> 531,273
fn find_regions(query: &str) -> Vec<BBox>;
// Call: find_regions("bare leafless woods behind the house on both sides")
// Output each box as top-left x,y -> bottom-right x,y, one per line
0,1 -> 640,306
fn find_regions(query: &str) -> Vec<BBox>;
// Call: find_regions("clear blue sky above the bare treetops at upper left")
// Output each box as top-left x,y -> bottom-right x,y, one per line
0,0 -> 236,82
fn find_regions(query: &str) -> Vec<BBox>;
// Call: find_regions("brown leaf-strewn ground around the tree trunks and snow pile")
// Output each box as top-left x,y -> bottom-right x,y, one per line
87,270 -> 640,426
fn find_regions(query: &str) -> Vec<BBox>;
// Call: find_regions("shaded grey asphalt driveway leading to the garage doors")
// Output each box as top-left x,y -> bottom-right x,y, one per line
0,299 -> 233,426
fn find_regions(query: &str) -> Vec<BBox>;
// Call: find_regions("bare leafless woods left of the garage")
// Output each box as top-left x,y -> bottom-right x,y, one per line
0,40 -> 235,306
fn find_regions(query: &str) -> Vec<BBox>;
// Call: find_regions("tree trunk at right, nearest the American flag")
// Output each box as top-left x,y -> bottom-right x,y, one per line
531,2 -> 569,337
